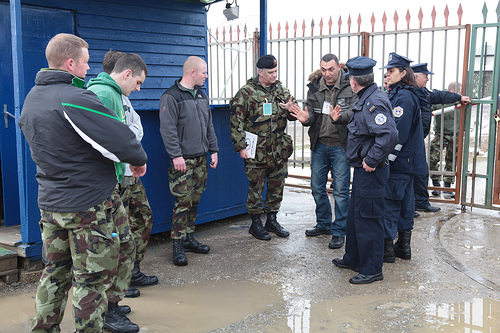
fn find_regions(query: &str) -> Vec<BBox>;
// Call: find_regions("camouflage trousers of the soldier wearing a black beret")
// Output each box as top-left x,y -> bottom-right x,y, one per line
245,161 -> 288,214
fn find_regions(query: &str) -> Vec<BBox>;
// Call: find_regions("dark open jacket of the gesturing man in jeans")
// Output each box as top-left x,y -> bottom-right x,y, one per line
303,69 -> 357,150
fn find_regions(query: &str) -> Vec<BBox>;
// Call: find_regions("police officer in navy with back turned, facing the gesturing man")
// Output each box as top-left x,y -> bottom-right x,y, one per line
331,57 -> 398,284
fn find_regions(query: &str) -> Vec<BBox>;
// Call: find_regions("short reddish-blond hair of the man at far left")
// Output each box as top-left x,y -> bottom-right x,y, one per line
45,33 -> 89,68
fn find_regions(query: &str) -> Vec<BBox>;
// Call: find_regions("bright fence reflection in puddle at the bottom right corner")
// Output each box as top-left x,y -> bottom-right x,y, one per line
424,299 -> 500,332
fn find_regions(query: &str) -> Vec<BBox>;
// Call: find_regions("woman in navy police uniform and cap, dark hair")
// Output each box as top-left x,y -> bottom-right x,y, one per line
383,52 -> 428,262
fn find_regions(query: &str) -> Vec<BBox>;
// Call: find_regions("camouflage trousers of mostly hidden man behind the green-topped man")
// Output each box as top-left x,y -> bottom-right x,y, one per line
121,177 -> 153,262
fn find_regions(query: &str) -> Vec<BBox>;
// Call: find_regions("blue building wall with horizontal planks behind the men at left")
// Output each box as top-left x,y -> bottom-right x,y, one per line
0,0 -> 248,256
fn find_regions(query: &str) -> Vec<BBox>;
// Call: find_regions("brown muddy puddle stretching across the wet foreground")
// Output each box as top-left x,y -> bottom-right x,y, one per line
0,280 -> 500,333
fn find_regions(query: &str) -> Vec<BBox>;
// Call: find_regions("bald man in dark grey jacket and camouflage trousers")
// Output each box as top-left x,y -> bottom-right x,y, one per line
160,56 -> 219,266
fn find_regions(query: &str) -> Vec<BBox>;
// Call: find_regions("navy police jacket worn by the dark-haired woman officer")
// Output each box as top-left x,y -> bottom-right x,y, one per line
389,82 -> 427,175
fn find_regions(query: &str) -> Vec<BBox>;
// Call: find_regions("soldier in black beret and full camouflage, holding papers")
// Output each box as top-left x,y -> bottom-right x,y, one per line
231,54 -> 296,240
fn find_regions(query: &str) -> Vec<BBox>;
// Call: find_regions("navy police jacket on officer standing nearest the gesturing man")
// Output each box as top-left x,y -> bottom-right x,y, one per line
346,83 -> 398,168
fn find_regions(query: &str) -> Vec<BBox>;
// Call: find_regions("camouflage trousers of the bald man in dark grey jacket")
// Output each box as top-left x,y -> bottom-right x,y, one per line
168,155 -> 208,239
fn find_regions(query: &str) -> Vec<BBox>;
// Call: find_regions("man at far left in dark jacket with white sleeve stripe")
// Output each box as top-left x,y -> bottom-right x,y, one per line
19,34 -> 147,332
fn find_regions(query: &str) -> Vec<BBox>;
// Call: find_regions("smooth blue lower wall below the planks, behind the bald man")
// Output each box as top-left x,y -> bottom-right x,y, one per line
139,106 -> 248,233
